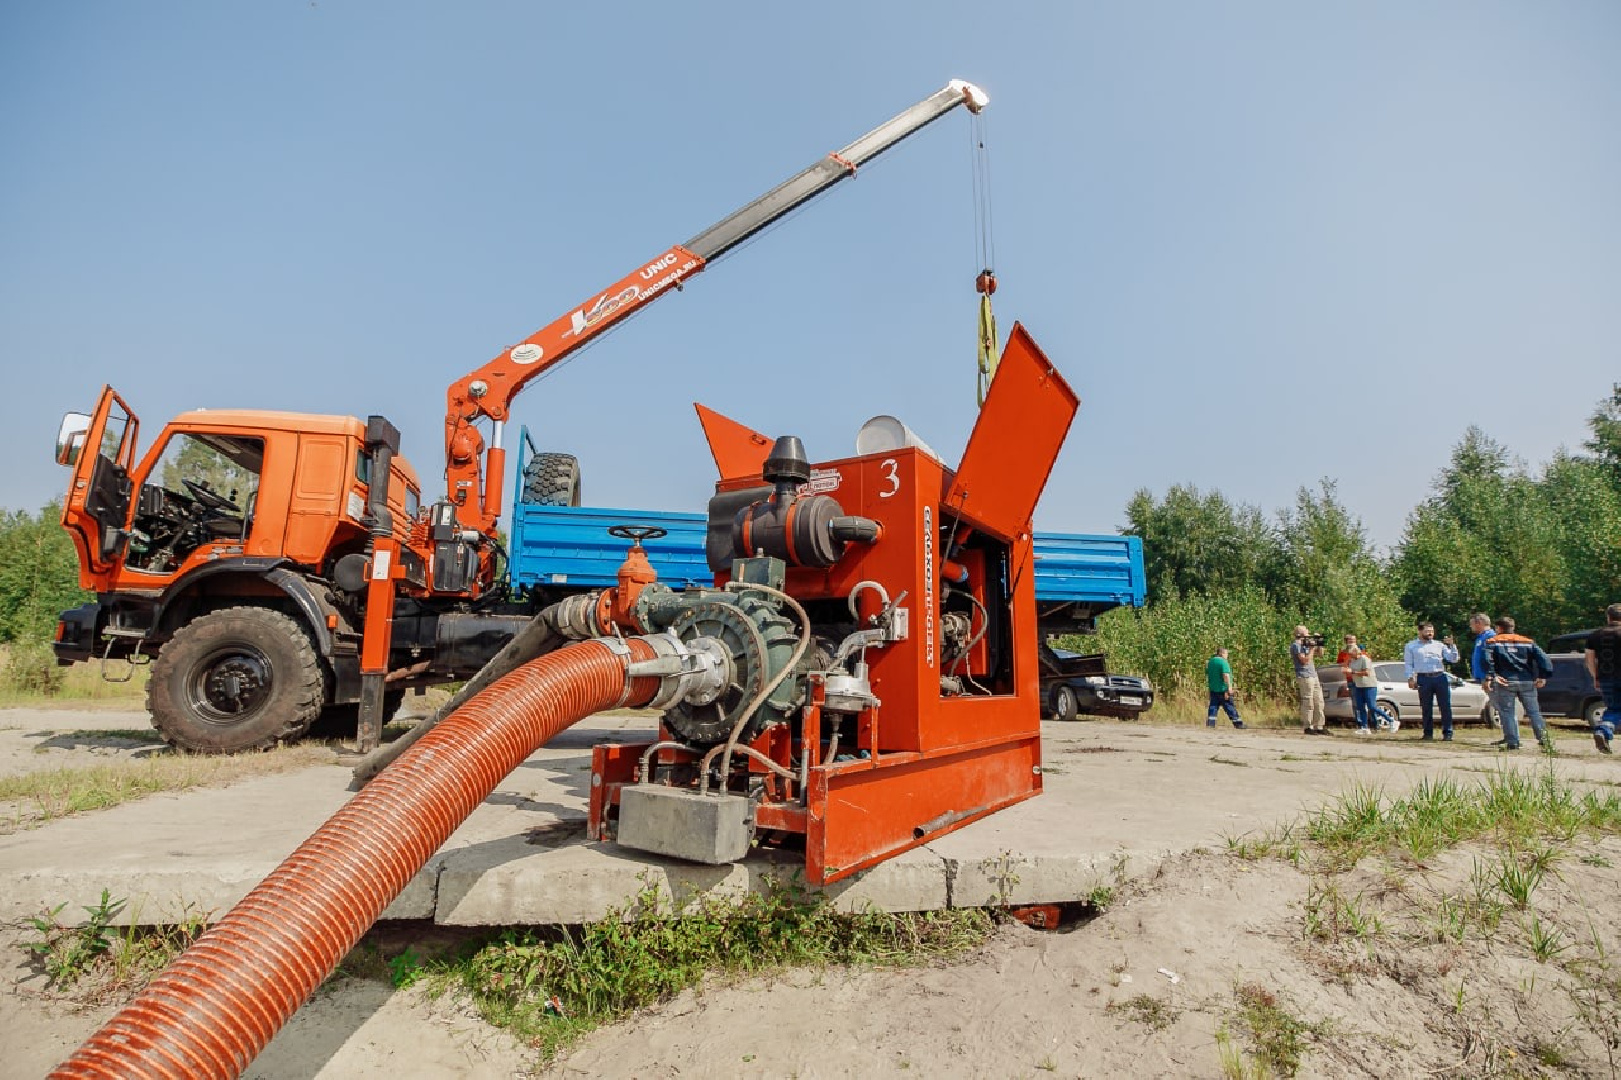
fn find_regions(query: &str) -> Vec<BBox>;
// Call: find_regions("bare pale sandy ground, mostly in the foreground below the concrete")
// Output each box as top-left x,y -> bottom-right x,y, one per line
0,710 -> 1621,1080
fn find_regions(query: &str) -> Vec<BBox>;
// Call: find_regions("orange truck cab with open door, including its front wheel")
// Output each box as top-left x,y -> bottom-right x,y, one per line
55,388 -> 428,749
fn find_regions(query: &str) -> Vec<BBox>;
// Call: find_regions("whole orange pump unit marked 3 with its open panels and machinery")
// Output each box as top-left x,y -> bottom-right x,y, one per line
559,326 -> 1078,884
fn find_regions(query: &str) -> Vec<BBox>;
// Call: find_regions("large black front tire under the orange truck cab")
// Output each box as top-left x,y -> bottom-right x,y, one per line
146,606 -> 326,754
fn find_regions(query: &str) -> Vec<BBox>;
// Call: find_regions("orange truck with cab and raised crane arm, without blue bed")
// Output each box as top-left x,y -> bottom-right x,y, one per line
55,81 -> 987,752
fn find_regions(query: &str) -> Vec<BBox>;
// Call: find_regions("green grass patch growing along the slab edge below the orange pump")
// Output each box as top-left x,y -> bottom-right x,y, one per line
414,887 -> 995,1057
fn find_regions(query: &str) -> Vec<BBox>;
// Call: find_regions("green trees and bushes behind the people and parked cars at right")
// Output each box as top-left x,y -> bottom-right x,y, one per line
1068,383 -> 1621,697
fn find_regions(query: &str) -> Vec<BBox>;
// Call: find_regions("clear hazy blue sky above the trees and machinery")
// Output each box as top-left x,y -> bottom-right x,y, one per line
0,0 -> 1621,545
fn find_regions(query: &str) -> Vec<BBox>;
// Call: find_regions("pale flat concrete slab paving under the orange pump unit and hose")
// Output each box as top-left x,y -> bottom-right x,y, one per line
0,714 -> 1621,926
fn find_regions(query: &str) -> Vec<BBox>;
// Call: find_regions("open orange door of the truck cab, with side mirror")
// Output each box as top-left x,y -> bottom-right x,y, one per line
57,386 -> 139,577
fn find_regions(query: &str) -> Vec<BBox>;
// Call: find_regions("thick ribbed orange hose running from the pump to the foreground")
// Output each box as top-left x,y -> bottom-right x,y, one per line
50,637 -> 661,1080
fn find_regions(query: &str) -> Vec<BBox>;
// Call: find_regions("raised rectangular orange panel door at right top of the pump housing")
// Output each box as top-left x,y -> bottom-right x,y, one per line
942,323 -> 1081,542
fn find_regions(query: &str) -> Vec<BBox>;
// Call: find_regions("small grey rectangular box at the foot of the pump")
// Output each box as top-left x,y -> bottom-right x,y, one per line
616,783 -> 754,866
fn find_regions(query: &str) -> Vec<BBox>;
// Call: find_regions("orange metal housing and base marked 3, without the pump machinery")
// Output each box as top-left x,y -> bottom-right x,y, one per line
590,326 -> 1080,885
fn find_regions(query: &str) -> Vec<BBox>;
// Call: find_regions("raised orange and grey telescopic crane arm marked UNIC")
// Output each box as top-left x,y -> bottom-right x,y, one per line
444,79 -> 989,535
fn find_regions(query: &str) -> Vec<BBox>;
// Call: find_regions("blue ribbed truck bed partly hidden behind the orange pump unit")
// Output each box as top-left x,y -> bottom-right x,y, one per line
511,503 -> 1144,632
